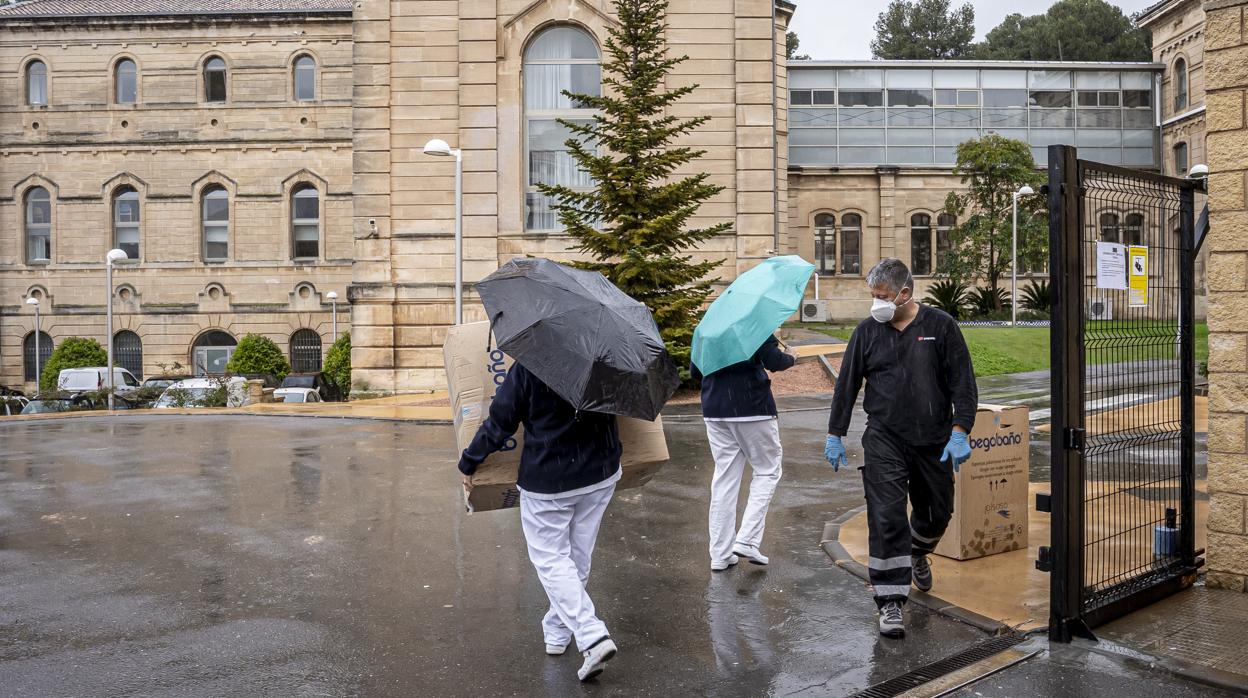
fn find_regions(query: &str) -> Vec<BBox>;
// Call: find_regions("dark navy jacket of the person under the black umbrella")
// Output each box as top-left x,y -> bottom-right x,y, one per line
459,363 -> 620,494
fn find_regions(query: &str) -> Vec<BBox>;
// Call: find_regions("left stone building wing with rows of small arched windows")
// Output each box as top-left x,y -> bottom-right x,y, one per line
0,0 -> 354,388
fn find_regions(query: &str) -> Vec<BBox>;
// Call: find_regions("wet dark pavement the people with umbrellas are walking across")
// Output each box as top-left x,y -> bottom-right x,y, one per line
0,407 -> 1228,697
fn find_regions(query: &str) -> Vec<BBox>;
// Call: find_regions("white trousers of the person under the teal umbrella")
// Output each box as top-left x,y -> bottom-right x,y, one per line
706,420 -> 784,563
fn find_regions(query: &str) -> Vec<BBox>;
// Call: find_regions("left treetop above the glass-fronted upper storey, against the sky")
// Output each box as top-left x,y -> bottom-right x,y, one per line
871,0 -> 975,60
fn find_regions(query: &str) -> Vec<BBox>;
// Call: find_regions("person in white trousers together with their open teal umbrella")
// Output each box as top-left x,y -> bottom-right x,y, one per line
690,256 -> 815,572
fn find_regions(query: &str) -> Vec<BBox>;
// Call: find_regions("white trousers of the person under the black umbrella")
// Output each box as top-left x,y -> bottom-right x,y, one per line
520,483 -> 615,652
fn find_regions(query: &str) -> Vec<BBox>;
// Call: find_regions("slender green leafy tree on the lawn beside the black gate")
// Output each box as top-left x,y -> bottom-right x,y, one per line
943,134 -> 1048,310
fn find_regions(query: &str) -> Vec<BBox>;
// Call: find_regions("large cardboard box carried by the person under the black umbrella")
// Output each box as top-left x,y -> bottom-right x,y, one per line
442,322 -> 668,512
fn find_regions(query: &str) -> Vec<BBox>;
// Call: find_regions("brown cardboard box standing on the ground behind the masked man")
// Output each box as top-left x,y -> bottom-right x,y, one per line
936,405 -> 1031,559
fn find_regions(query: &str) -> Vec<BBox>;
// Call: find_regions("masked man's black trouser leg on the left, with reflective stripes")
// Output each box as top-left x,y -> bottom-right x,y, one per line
862,428 -> 911,606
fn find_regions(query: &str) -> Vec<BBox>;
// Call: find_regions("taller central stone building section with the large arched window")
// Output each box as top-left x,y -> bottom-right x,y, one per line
351,0 -> 794,392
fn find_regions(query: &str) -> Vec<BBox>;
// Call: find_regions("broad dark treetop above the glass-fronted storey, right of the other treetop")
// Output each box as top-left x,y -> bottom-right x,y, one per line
975,0 -> 1153,61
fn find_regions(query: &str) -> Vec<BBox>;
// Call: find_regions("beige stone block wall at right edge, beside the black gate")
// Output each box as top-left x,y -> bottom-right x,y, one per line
1204,0 -> 1248,591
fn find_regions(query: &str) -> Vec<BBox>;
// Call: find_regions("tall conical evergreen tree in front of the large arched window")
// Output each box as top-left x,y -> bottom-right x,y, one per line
539,0 -> 733,372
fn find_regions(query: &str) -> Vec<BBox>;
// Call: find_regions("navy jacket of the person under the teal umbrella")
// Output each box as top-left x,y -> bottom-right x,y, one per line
690,336 -> 795,420
